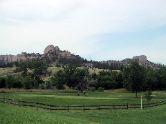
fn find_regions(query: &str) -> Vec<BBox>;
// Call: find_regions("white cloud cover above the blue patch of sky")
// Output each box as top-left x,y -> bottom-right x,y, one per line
0,0 -> 166,63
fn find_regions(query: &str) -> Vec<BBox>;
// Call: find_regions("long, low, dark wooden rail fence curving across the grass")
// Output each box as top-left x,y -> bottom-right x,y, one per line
0,97 -> 166,111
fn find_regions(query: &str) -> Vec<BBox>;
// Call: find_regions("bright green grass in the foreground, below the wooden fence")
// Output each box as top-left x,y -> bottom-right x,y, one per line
0,103 -> 166,124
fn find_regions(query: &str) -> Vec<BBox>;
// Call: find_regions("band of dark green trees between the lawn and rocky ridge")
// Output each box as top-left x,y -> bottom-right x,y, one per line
0,59 -> 166,95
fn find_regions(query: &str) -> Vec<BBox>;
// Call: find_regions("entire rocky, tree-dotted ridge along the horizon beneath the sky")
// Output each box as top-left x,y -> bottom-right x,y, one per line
0,45 -> 162,70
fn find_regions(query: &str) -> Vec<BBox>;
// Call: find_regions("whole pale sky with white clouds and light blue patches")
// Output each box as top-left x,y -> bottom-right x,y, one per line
0,0 -> 166,64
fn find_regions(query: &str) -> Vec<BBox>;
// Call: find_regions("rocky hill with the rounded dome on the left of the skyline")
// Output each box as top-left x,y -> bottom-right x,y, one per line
0,45 -> 85,67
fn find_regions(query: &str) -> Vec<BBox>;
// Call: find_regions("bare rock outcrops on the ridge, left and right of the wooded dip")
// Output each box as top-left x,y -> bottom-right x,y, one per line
0,45 -> 161,68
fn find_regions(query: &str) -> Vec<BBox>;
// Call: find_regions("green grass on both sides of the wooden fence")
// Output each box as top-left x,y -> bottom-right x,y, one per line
0,90 -> 166,124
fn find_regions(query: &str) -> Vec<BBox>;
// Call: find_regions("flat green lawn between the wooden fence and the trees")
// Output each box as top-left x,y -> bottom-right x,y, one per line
0,91 -> 166,105
